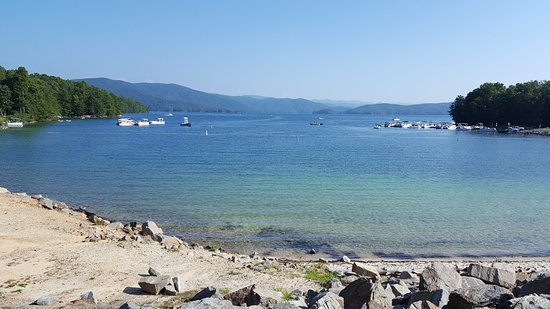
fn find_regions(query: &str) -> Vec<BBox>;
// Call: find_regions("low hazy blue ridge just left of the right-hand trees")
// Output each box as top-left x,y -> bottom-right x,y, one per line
345,103 -> 451,115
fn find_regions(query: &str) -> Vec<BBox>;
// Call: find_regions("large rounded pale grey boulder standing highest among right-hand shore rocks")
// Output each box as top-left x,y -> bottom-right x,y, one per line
420,263 -> 462,292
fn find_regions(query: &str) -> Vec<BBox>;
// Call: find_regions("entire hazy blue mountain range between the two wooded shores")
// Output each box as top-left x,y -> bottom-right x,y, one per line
75,78 -> 450,115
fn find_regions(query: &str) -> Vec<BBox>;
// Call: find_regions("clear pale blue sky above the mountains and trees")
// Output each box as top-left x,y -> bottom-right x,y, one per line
0,0 -> 550,103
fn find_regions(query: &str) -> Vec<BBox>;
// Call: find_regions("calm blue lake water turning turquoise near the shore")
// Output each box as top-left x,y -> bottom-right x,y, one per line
0,114 -> 550,258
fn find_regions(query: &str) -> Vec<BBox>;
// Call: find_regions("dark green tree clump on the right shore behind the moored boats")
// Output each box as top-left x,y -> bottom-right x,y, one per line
449,81 -> 550,127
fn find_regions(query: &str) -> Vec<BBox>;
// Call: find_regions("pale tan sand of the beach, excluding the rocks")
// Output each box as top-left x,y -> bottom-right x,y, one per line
0,186 -> 550,308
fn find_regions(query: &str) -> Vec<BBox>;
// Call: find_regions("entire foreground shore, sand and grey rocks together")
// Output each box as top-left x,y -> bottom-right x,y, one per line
0,188 -> 550,309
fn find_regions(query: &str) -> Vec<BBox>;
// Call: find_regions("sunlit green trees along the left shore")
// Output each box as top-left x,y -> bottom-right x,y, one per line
0,66 -> 148,121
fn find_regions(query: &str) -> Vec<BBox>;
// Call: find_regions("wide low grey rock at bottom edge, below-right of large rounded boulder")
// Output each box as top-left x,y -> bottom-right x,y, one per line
445,284 -> 514,309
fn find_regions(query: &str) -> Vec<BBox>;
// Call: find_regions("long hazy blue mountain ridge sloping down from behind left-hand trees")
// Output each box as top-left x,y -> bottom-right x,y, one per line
78,78 -> 327,114
